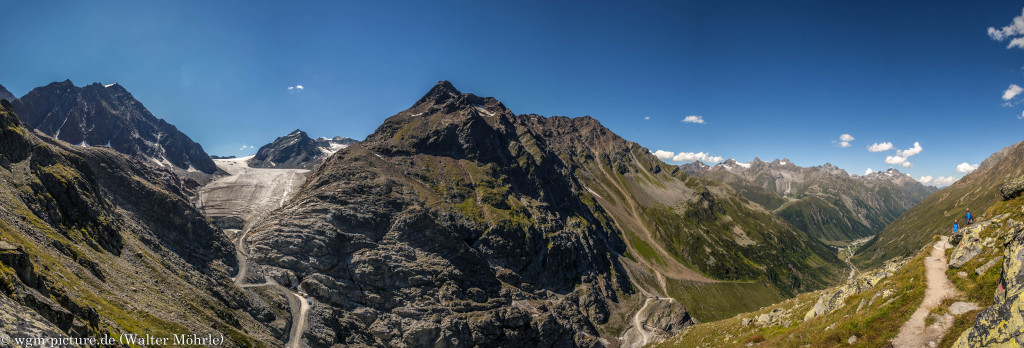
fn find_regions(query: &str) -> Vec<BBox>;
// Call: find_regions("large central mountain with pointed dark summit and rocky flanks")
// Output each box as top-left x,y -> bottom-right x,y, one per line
241,82 -> 841,347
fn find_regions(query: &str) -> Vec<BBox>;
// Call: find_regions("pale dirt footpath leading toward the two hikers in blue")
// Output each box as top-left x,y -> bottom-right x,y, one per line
893,235 -> 958,348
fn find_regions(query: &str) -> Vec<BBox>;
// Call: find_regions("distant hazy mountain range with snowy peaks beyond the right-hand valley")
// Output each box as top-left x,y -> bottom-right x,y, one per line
697,159 -> 935,242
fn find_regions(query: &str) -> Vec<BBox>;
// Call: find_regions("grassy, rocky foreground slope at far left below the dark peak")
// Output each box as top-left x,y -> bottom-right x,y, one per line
0,101 -> 285,346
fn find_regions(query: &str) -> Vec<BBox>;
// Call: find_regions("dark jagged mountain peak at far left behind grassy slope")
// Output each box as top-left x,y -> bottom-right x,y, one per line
13,81 -> 217,174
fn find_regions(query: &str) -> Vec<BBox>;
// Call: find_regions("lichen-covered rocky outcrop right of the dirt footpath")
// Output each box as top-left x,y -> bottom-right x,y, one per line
955,216 -> 1024,348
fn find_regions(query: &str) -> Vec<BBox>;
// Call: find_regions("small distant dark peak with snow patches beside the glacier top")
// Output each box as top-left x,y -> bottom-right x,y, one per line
249,129 -> 355,169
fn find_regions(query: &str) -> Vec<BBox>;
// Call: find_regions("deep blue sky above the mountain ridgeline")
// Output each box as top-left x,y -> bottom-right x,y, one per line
0,1 -> 1024,186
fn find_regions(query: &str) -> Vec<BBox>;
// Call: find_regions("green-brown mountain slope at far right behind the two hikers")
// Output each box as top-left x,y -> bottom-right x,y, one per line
854,142 -> 1024,266
